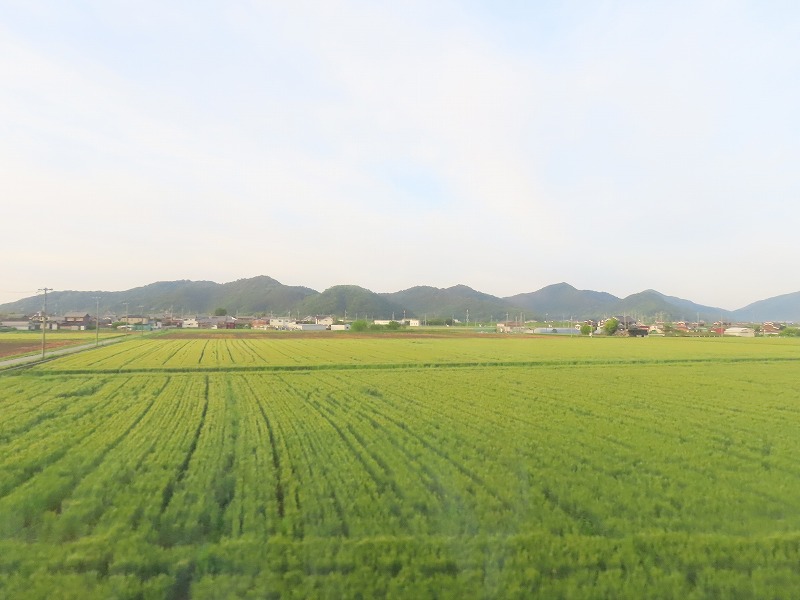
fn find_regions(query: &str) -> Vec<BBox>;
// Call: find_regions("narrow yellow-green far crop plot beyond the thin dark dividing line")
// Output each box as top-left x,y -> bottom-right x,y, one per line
28,336 -> 800,372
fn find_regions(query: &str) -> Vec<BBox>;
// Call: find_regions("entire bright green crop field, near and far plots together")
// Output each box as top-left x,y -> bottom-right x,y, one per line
0,335 -> 800,598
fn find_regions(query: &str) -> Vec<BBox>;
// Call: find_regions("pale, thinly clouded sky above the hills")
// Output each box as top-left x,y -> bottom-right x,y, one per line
0,0 -> 800,310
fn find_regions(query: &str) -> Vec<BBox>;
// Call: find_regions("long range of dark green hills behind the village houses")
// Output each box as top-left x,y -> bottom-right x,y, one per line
0,275 -> 800,322
